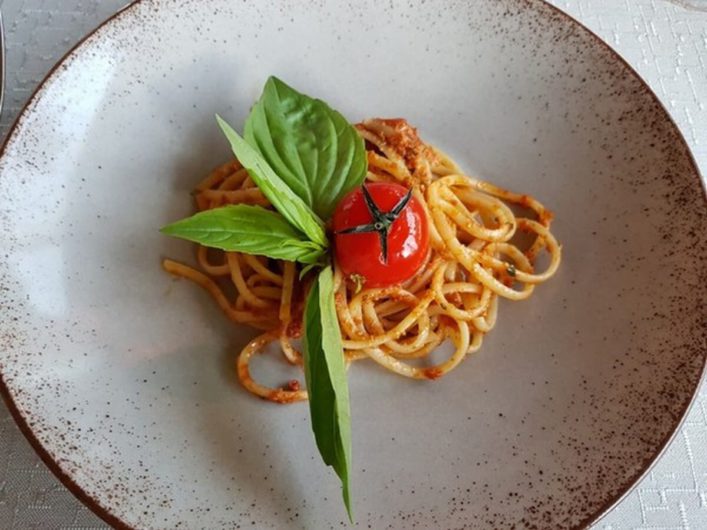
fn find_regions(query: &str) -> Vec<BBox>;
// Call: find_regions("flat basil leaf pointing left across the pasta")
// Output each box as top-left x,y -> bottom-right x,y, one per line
161,204 -> 326,264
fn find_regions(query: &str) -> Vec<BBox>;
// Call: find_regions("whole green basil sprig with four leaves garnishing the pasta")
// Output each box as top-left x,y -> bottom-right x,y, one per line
162,77 -> 367,520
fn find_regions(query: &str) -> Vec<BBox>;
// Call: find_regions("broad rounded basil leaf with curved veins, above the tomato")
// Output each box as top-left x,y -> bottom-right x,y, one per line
244,77 -> 368,219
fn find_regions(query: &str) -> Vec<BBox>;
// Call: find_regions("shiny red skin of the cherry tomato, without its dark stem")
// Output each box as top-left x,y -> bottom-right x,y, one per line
332,182 -> 429,287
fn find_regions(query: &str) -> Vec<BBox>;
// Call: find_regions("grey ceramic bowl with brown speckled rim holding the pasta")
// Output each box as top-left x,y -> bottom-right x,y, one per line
0,0 -> 707,529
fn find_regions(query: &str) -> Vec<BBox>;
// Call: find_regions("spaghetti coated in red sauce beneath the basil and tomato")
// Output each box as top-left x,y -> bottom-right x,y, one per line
163,119 -> 561,403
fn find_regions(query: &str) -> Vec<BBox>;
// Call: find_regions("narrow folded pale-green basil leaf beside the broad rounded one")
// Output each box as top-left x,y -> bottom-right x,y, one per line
216,115 -> 329,247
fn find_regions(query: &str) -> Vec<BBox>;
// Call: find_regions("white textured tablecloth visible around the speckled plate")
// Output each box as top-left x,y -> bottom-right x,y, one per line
0,0 -> 707,530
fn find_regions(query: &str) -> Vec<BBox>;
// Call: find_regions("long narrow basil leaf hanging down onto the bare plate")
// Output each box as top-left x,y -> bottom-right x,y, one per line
303,266 -> 353,522
